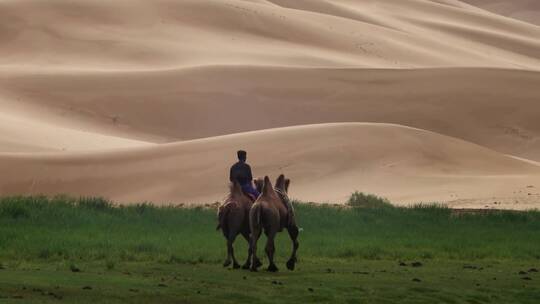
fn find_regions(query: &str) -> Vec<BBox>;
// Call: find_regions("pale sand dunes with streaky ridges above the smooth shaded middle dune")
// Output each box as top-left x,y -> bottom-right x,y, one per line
0,0 -> 540,70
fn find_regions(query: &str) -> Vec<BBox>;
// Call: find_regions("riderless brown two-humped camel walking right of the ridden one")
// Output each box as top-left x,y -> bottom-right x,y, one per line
249,174 -> 299,272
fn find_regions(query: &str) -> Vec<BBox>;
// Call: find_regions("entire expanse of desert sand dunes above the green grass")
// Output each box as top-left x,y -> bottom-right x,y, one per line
0,0 -> 540,210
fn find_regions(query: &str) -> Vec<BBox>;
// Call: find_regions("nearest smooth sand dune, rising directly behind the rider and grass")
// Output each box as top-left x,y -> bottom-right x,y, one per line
0,123 -> 540,208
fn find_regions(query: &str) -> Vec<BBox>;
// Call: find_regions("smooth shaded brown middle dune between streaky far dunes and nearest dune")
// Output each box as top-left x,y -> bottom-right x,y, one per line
0,67 -> 540,160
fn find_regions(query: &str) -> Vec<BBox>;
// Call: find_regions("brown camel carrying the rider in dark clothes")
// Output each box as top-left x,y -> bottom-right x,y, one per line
216,179 -> 262,269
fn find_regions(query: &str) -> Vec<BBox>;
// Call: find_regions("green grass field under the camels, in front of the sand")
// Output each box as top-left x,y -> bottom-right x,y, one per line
0,195 -> 540,303
